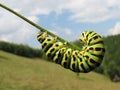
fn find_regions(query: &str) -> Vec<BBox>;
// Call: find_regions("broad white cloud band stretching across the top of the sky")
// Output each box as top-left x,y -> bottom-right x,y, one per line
1,0 -> 120,23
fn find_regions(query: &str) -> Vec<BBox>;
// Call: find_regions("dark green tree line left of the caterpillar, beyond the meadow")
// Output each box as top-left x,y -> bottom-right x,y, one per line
0,41 -> 43,58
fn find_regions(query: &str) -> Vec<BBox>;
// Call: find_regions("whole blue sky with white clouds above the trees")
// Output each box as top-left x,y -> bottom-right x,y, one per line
0,0 -> 120,48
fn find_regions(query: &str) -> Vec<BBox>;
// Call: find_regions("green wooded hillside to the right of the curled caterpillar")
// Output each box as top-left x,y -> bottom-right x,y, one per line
101,35 -> 120,80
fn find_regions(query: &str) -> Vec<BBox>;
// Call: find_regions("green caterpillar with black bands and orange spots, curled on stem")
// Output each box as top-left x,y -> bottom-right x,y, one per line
37,31 -> 105,73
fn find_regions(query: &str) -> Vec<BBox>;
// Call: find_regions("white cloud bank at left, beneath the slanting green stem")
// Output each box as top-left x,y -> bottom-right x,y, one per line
0,8 -> 38,46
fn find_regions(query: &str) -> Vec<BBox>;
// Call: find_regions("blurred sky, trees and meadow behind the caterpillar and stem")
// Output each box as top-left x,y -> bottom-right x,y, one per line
0,0 -> 120,90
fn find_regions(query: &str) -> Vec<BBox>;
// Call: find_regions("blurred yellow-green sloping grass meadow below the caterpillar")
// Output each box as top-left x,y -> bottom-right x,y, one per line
0,51 -> 120,90
